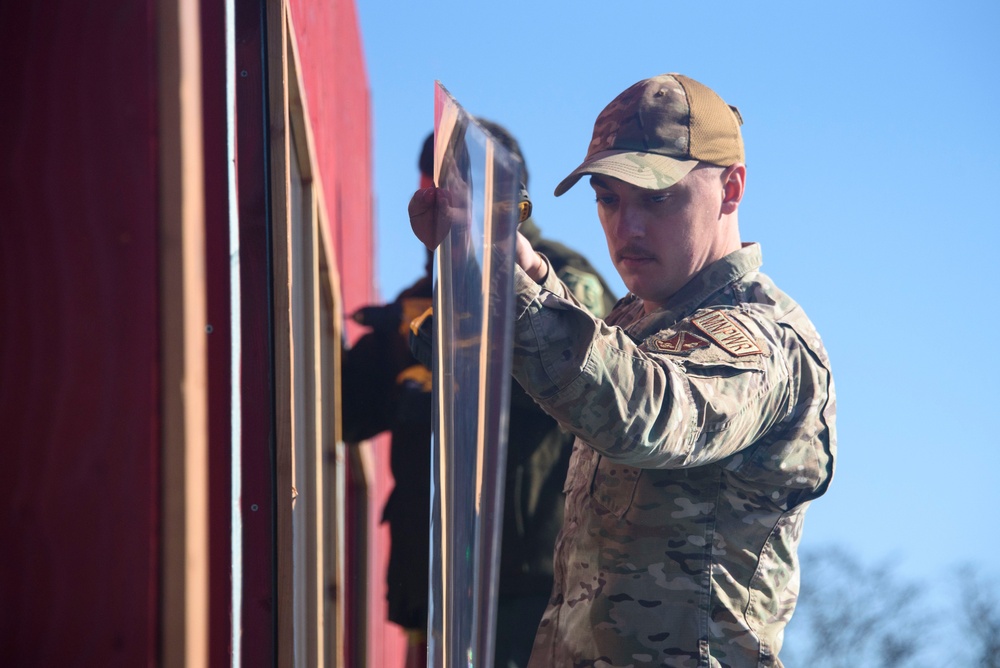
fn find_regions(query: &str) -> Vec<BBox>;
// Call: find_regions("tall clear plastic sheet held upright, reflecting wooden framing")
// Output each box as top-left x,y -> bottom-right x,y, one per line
428,83 -> 523,668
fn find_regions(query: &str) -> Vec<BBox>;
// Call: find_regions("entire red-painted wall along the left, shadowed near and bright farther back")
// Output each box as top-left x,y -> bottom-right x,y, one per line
0,0 -> 390,667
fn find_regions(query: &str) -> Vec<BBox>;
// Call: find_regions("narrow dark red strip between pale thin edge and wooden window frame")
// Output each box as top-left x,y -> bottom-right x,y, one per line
235,0 -> 277,666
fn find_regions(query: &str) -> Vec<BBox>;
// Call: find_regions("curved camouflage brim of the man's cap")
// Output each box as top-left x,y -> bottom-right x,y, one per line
555,151 -> 698,197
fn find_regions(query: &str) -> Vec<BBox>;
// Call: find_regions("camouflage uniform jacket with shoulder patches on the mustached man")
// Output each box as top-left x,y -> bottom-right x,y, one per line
514,244 -> 836,668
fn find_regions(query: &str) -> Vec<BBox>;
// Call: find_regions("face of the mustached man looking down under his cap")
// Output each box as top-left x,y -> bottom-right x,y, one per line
590,166 -> 729,313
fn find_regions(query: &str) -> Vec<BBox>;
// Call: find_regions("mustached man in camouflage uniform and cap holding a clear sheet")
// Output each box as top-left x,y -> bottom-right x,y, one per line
411,74 -> 836,668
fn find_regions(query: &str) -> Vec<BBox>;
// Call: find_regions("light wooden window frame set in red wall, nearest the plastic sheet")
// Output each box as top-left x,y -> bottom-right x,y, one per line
267,1 -> 345,666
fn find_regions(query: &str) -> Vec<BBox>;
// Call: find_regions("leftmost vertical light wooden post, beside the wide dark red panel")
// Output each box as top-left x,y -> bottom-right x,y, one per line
157,0 -> 208,668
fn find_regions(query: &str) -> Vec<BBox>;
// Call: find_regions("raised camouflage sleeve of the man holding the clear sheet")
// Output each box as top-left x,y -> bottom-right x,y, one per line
514,269 -> 789,468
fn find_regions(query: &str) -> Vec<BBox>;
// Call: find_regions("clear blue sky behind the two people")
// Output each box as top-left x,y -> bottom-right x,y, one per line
357,0 -> 1000,578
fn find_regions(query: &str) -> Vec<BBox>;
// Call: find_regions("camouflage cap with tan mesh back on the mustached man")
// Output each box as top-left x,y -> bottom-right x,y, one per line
555,74 -> 744,197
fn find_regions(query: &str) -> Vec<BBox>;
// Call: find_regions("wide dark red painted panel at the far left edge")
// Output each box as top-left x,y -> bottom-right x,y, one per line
0,0 -> 160,666
